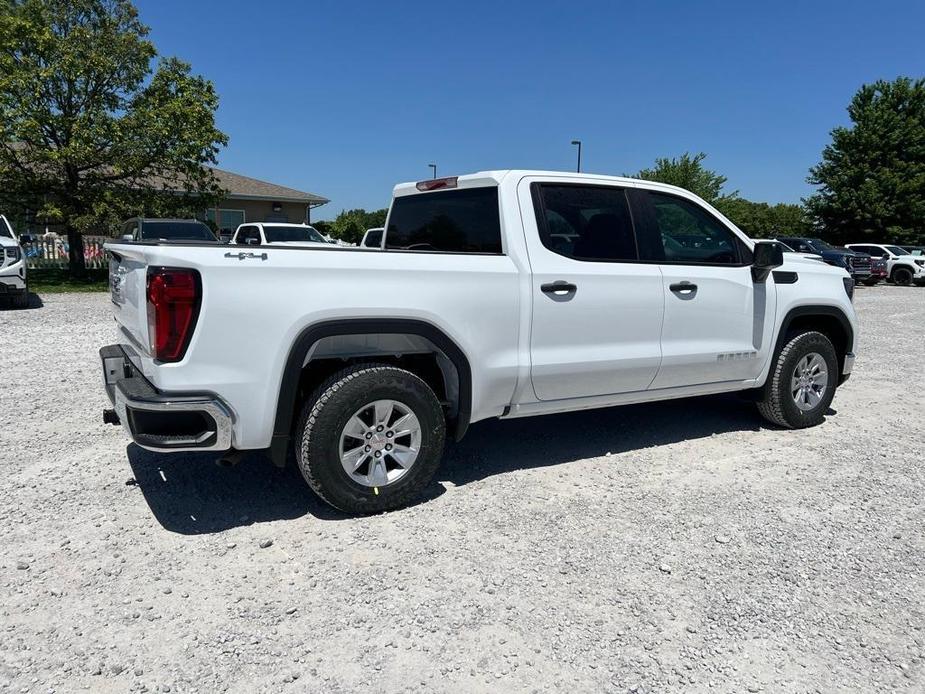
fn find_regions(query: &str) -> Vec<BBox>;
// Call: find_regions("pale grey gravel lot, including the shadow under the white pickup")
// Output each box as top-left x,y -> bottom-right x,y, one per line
0,286 -> 925,692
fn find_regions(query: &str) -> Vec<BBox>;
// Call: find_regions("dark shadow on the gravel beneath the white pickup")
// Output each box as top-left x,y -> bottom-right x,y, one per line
127,396 -> 761,535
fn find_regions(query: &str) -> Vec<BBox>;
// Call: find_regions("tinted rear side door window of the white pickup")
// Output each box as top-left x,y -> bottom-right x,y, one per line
534,184 -> 639,261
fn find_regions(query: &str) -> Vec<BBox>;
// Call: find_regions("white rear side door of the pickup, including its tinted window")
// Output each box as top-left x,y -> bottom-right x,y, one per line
518,178 -> 664,400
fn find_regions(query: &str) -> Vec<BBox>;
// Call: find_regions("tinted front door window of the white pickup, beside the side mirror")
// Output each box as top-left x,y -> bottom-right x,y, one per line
648,192 -> 742,265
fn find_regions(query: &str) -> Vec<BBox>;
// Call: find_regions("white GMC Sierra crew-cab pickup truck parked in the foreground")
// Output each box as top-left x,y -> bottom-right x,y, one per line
100,171 -> 857,513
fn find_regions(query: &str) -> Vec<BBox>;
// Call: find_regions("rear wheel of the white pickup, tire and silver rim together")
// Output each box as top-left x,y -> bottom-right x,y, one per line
296,364 -> 446,513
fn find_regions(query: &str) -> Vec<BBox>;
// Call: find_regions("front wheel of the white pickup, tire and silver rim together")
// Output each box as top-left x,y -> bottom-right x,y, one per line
757,331 -> 838,429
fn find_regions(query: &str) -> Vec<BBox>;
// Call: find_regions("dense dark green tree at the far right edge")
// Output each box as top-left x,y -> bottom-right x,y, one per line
805,77 -> 925,244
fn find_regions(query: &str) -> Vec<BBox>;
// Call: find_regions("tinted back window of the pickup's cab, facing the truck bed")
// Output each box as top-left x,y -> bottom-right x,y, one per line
385,187 -> 501,253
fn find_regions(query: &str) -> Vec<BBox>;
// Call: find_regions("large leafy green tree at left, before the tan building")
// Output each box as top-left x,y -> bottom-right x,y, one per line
0,0 -> 227,275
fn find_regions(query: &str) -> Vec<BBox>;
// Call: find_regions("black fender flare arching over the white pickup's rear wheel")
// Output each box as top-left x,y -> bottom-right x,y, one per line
270,318 -> 472,466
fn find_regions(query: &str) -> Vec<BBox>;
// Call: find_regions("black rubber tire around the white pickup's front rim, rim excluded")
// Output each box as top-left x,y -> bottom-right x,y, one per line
757,331 -> 839,429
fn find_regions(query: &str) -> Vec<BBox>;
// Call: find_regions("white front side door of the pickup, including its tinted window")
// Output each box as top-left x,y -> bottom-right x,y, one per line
634,189 -> 776,389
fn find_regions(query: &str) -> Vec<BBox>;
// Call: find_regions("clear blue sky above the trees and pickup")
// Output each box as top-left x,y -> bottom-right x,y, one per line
137,0 -> 925,219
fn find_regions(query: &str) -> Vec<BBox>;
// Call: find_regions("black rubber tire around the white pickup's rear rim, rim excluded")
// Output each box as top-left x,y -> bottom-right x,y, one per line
295,364 -> 446,514
